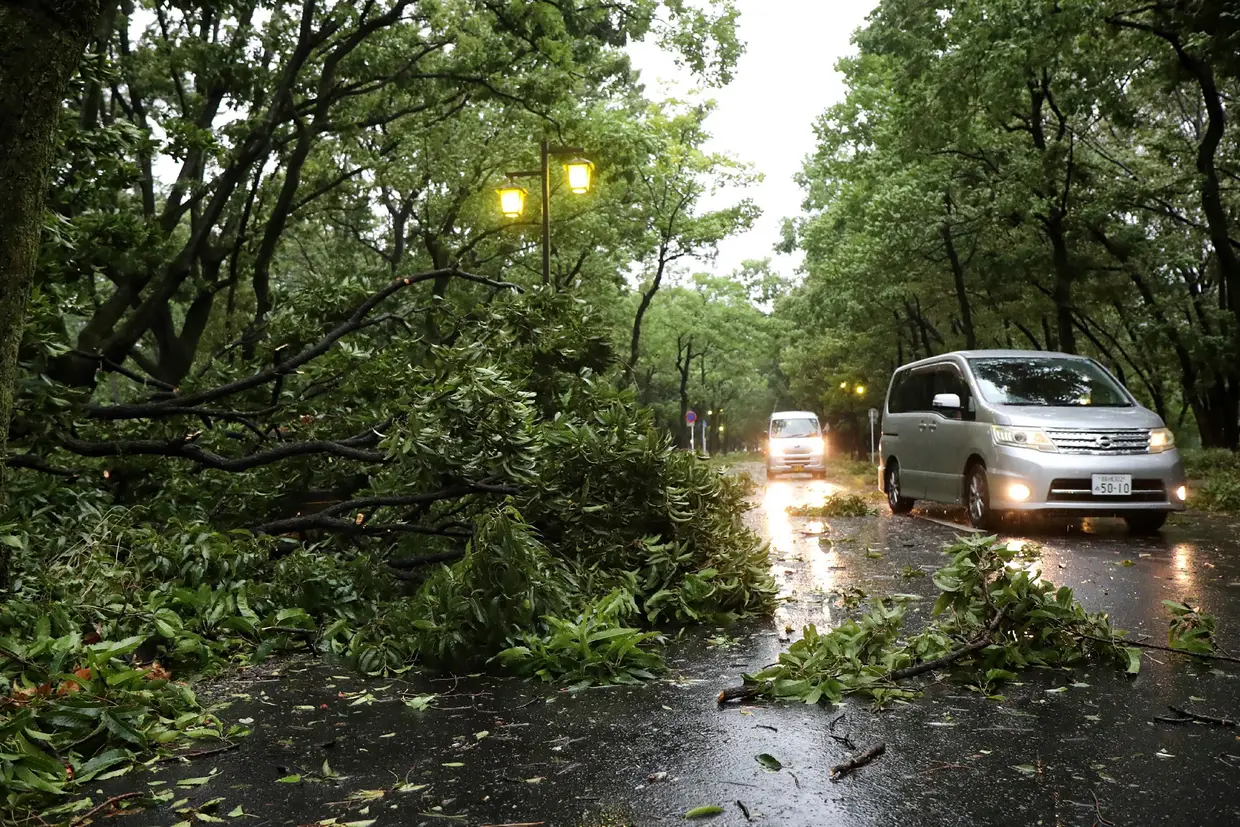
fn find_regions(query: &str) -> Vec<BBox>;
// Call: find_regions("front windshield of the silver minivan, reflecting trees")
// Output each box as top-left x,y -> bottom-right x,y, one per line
968,356 -> 1132,408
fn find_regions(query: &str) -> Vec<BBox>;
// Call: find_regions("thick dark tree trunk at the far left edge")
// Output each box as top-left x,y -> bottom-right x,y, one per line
0,0 -> 99,513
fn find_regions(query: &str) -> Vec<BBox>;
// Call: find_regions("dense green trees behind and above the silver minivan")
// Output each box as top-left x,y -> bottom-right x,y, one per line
779,0 -> 1240,449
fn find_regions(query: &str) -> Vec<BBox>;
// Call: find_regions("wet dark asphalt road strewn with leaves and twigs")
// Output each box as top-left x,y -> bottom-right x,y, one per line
97,470 -> 1240,827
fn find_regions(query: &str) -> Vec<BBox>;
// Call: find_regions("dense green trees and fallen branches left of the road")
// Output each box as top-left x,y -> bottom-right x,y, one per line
0,0 -> 775,818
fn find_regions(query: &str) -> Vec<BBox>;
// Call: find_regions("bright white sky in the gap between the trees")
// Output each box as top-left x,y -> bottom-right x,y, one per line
629,0 -> 878,278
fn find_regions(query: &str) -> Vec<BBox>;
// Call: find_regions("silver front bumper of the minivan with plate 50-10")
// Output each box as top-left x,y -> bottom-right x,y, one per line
986,448 -> 1187,516
